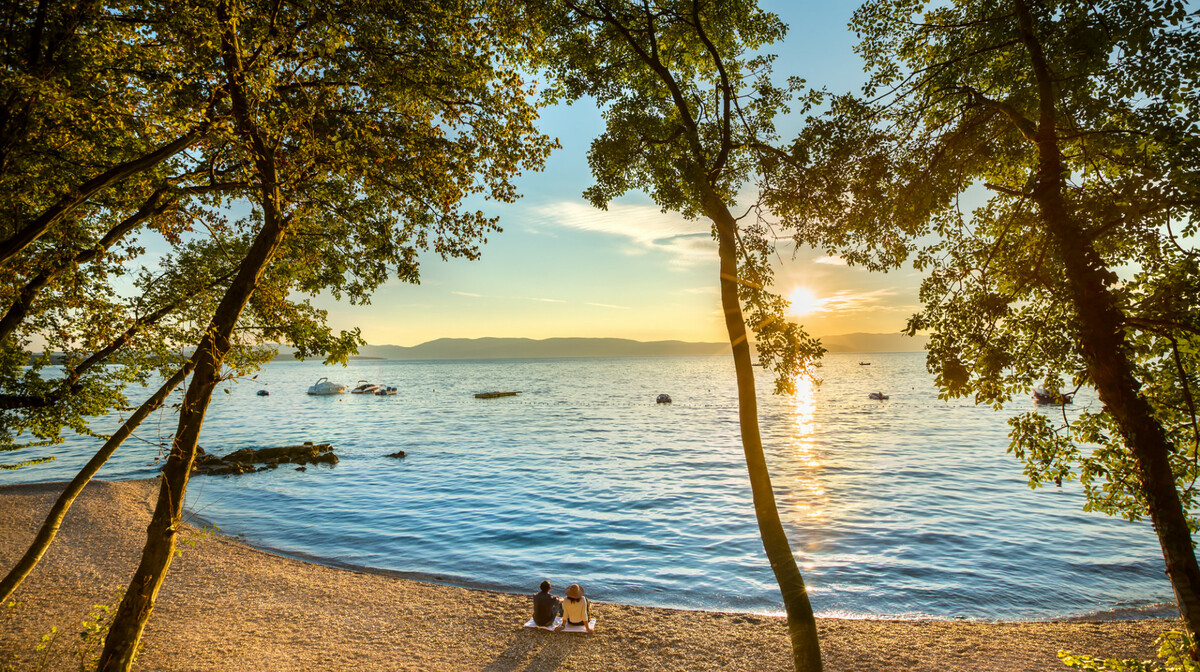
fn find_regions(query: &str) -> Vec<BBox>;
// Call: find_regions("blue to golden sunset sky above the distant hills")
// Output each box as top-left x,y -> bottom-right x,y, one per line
314,5 -> 920,346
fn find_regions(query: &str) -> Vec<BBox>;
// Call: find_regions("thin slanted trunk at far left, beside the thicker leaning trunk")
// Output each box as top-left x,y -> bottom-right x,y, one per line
0,361 -> 192,602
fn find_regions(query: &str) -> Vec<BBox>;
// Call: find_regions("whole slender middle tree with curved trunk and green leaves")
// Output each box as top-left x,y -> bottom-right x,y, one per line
530,0 -> 822,671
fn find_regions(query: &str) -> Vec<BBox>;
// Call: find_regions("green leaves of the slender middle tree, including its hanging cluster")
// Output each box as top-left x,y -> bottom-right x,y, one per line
530,0 -> 824,392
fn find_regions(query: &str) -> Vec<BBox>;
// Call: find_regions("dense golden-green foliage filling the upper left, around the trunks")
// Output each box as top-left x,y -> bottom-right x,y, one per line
0,0 -> 551,468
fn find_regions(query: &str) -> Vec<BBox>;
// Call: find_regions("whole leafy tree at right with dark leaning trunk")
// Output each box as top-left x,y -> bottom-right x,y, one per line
764,0 -> 1200,641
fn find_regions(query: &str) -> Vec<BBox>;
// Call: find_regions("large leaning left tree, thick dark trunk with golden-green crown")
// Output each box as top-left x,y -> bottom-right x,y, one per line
98,0 -> 550,671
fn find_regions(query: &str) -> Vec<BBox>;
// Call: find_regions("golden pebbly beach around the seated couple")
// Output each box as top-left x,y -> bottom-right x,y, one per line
0,480 -> 1177,672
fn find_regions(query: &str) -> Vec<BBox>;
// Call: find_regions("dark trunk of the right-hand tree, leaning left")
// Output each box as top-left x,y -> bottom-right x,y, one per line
1014,0 -> 1200,659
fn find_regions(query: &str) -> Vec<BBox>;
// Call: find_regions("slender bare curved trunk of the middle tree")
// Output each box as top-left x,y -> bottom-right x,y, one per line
704,193 -> 822,672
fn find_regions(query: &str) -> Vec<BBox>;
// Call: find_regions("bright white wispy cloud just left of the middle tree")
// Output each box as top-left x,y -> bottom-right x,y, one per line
532,202 -> 716,265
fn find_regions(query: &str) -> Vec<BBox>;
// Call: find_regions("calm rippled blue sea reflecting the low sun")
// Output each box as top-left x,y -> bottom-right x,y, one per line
0,353 -> 1171,619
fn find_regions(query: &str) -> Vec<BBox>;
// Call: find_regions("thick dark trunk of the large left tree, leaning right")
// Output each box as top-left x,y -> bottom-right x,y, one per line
96,0 -> 286,672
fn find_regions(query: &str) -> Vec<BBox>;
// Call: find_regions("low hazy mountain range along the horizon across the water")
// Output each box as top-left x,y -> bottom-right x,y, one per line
270,334 -> 928,359
